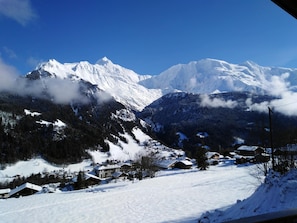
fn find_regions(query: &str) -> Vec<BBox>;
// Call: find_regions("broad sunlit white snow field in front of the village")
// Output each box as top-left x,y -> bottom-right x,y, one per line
0,165 -> 260,223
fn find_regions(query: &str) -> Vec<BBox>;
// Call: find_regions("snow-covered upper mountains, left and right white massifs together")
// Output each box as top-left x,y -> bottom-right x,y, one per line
27,57 -> 297,111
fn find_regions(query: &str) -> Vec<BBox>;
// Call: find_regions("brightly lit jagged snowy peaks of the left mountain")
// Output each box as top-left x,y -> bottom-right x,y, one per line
31,57 -> 162,110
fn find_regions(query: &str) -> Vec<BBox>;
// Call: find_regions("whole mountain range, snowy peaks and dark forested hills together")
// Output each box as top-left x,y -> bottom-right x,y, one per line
0,57 -> 297,163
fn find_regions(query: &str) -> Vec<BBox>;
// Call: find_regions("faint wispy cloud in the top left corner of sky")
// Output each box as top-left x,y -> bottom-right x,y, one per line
0,0 -> 36,26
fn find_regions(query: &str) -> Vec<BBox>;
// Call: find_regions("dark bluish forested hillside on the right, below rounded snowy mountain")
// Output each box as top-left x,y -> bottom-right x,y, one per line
139,92 -> 297,154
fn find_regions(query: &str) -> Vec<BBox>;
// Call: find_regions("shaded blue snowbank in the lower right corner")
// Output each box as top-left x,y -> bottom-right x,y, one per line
201,169 -> 297,223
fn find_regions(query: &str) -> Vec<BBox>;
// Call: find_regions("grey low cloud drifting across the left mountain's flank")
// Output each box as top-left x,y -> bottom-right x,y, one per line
0,60 -> 111,104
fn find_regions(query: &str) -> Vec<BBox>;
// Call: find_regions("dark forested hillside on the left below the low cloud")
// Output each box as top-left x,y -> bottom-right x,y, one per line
0,93 -> 137,164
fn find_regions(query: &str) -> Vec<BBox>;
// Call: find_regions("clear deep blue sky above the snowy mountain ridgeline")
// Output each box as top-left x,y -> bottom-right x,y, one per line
0,0 -> 297,74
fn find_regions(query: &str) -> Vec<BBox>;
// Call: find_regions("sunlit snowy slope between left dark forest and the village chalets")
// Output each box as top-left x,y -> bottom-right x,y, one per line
0,125 -> 180,181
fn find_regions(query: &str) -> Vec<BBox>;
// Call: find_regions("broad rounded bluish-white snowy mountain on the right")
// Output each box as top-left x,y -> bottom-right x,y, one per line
141,59 -> 297,94
